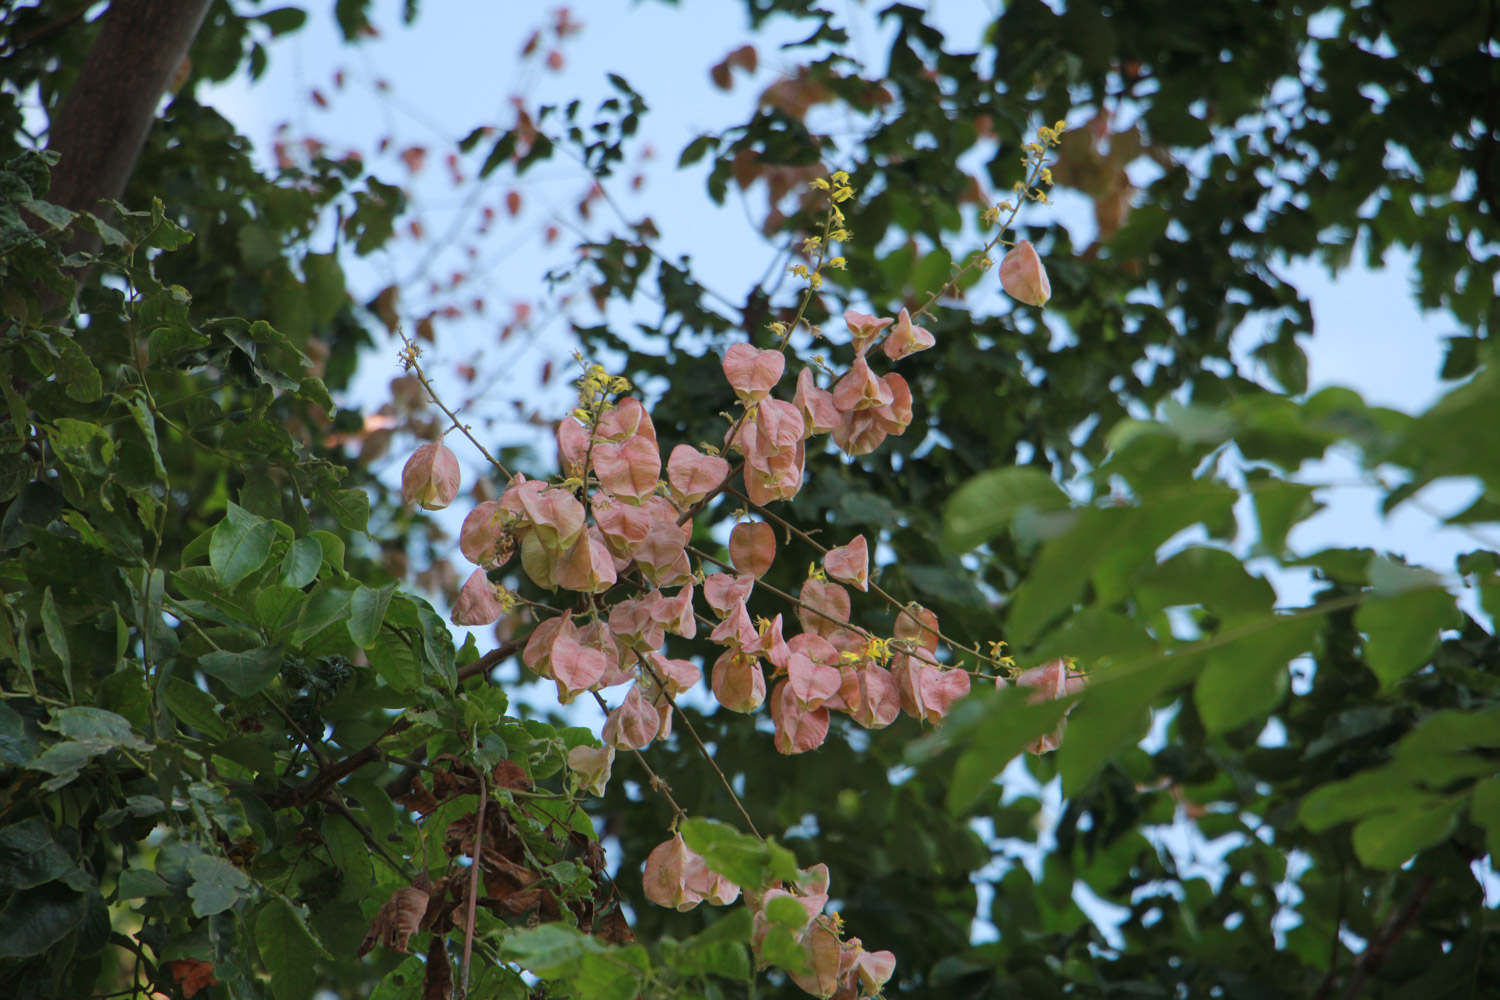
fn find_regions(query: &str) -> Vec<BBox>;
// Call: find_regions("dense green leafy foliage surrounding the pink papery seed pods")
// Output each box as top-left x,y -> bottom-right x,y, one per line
0,3 -> 1500,999
